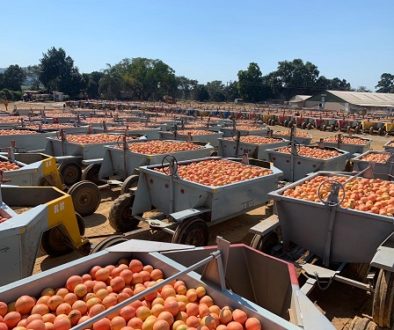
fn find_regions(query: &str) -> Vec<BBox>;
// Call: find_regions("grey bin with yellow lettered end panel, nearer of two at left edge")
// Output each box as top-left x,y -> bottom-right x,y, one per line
0,185 -> 90,286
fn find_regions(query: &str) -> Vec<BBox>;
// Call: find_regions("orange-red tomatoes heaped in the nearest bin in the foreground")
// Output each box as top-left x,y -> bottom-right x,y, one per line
0,258 -> 261,330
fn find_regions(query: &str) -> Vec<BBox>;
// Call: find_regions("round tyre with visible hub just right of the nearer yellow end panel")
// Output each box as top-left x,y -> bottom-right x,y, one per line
68,180 -> 101,216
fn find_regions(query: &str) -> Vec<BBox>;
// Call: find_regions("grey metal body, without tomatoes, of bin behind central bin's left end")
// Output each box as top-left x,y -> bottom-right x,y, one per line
99,141 -> 214,179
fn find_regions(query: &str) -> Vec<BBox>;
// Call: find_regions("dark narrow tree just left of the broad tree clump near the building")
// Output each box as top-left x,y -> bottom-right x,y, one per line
238,62 -> 263,102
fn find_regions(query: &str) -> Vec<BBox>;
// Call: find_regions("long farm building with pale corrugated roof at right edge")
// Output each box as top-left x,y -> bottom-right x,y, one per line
305,90 -> 394,112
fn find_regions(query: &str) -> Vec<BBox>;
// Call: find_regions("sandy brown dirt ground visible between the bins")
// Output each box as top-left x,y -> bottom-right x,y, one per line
4,103 -> 390,329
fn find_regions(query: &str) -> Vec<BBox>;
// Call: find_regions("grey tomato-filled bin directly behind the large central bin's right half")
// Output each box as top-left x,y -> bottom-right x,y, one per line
219,135 -> 290,161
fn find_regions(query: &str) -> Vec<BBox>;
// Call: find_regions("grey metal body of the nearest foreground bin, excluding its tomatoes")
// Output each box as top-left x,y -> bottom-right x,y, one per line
0,240 -> 334,330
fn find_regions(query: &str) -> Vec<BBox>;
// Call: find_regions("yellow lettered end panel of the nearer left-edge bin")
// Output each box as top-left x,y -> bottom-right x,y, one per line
46,188 -> 86,248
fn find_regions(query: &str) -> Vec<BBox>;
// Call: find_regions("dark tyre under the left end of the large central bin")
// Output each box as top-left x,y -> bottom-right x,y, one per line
108,194 -> 139,233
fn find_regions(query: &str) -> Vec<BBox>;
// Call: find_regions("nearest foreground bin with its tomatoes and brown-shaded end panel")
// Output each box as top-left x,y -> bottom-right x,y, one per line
0,239 -> 335,330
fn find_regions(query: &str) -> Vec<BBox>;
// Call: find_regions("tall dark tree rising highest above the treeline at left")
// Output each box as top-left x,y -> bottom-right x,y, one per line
39,47 -> 82,97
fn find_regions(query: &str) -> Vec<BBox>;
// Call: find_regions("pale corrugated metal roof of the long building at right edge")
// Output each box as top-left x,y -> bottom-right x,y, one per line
327,90 -> 394,107
